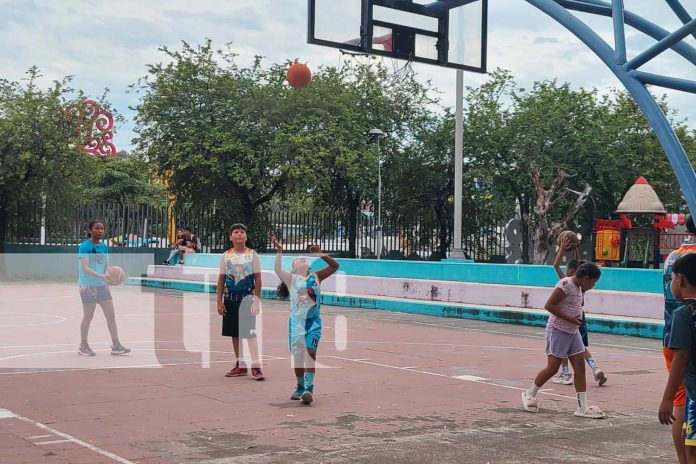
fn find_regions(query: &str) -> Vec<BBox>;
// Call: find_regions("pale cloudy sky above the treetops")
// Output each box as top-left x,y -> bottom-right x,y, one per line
0,0 -> 696,149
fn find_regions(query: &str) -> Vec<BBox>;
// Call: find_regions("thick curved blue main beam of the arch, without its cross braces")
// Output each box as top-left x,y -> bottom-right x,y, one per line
527,0 -> 696,213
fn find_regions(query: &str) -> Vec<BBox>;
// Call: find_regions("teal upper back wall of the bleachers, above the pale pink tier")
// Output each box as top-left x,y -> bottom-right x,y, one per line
186,253 -> 662,293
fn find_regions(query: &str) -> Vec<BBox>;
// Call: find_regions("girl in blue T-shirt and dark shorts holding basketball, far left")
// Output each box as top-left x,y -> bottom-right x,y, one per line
77,221 -> 130,356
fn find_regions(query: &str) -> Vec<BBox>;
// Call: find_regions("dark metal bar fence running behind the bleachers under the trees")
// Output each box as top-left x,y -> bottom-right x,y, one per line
2,201 -> 505,262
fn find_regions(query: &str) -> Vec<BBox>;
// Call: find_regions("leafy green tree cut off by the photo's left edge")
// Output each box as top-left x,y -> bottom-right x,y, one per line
0,67 -> 96,260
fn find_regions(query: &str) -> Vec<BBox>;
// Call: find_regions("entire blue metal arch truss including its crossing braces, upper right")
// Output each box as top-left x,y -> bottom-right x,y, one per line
426,0 -> 696,214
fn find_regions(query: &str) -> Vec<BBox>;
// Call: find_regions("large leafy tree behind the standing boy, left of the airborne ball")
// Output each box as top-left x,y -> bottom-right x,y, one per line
134,41 -> 320,246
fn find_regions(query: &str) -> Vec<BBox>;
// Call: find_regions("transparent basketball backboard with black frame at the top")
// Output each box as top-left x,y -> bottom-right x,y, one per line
307,0 -> 488,73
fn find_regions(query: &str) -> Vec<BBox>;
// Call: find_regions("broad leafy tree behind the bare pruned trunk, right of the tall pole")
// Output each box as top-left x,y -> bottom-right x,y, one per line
465,70 -> 694,262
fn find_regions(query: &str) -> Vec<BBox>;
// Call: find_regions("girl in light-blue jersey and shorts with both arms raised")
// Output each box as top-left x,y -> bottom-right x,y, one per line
273,237 -> 338,404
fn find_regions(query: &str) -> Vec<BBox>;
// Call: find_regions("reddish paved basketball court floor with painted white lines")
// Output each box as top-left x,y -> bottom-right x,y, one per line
0,282 -> 674,464
